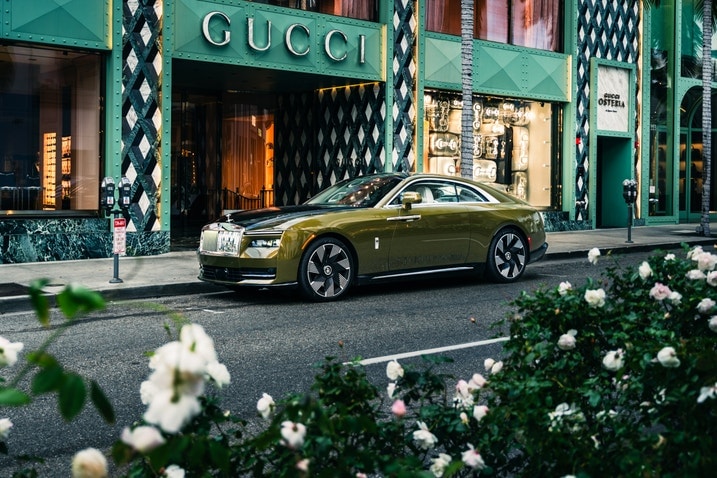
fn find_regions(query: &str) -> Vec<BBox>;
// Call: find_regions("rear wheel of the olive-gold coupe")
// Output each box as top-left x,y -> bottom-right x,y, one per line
486,228 -> 528,283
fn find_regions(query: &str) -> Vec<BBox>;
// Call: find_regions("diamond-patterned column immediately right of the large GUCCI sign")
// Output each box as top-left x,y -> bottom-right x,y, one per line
393,0 -> 417,171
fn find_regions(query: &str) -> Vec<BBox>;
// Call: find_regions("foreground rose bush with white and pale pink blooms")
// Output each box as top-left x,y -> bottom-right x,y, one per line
0,247 -> 717,477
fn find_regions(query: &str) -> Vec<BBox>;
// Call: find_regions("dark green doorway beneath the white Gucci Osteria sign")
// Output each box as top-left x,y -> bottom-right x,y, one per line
596,136 -> 632,227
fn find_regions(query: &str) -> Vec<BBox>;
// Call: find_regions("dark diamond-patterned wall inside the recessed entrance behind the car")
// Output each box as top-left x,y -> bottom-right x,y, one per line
274,83 -> 386,205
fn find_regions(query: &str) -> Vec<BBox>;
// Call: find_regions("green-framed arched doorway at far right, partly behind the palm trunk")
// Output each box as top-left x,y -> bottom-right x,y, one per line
679,87 -> 717,223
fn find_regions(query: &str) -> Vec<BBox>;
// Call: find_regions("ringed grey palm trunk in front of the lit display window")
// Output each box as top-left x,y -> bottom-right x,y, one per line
460,0 -> 473,178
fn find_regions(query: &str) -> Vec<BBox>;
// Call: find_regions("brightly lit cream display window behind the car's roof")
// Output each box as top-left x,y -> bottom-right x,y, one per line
424,91 -> 559,208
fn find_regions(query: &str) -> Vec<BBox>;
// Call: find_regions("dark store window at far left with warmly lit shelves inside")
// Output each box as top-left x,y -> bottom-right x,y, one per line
0,46 -> 101,215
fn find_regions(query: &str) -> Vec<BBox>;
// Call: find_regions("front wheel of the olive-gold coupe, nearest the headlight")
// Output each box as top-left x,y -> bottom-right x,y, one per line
299,237 -> 354,301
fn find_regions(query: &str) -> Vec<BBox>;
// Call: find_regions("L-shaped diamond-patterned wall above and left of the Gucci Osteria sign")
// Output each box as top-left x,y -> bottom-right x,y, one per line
575,0 -> 640,221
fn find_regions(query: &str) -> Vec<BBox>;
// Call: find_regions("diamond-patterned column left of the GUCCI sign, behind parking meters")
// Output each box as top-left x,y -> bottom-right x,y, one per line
122,0 -> 162,232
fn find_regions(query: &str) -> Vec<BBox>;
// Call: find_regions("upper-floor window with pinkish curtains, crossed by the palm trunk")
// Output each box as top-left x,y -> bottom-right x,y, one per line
426,0 -> 562,51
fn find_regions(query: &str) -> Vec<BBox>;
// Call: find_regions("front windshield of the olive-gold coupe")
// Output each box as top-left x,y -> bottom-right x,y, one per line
306,175 -> 404,207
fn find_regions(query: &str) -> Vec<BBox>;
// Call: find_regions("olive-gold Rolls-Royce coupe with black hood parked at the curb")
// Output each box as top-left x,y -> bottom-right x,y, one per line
198,173 -> 548,301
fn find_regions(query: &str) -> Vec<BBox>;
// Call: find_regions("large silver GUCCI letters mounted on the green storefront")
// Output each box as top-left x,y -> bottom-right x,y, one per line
202,11 -> 366,63
